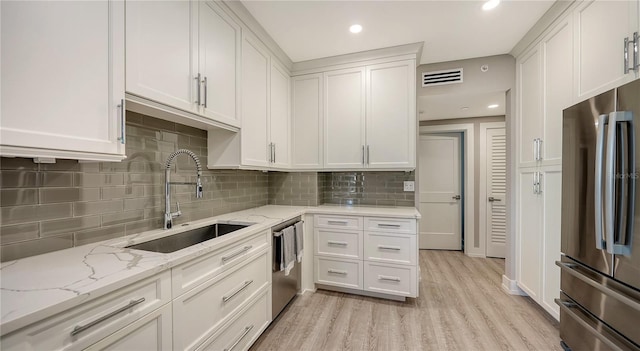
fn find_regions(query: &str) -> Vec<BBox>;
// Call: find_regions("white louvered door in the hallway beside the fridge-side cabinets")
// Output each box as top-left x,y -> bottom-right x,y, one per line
480,127 -> 507,258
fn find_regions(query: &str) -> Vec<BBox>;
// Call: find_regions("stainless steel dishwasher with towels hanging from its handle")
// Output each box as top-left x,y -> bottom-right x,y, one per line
271,217 -> 302,320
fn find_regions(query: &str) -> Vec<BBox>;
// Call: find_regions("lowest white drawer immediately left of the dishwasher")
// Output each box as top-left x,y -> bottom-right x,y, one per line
198,289 -> 270,351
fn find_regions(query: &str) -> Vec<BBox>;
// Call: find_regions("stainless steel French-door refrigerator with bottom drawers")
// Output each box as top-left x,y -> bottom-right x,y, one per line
556,80 -> 640,351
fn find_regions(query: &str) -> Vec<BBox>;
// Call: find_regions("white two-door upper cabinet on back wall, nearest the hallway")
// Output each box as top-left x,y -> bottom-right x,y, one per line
324,60 -> 417,169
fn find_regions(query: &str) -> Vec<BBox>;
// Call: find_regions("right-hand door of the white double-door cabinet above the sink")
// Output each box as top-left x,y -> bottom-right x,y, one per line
198,1 -> 241,123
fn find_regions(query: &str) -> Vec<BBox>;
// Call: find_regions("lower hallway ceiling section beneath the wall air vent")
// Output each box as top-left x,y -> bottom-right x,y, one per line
418,91 -> 505,121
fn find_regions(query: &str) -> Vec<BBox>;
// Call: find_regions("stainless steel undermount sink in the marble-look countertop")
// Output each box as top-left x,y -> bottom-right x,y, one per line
126,223 -> 251,253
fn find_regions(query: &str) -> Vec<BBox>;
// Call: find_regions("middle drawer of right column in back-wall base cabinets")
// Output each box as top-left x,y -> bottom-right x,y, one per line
364,232 -> 418,265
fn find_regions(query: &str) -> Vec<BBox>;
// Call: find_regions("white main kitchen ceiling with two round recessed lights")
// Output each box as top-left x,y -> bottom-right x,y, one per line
242,0 -> 553,64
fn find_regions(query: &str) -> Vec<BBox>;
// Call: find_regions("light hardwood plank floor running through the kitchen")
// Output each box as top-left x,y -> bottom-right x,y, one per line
251,250 -> 562,351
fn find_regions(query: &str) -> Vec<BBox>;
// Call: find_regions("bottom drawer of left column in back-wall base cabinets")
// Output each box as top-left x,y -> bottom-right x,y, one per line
315,257 -> 362,289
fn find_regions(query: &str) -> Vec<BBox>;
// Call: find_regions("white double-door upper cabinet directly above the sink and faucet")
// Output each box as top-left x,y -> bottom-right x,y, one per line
126,0 -> 241,126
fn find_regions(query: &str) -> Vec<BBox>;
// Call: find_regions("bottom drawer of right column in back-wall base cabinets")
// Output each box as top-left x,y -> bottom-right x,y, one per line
364,262 -> 418,297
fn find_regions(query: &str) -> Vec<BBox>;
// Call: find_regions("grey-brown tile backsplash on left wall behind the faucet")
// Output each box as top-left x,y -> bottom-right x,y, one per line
0,112 -> 269,261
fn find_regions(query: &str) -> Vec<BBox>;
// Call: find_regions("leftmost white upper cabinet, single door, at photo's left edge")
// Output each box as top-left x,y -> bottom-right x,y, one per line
0,1 -> 125,161
